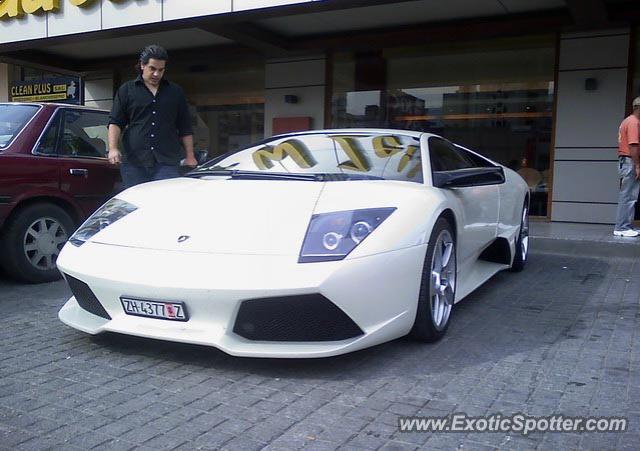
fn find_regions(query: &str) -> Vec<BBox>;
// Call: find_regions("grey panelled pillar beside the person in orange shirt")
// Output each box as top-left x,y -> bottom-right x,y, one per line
551,29 -> 630,223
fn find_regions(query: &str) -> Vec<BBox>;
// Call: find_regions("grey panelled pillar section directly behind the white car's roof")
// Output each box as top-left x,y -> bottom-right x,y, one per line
264,55 -> 327,137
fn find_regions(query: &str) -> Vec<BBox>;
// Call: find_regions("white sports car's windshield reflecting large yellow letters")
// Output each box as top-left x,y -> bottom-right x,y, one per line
192,131 -> 423,183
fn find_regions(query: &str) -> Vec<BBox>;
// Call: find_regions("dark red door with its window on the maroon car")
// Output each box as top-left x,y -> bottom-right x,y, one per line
38,108 -> 122,215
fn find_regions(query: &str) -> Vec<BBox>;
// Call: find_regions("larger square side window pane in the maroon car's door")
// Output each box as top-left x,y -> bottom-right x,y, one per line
58,110 -> 109,158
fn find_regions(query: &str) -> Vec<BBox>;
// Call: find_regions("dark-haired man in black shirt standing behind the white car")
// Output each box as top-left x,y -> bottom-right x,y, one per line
109,45 -> 197,188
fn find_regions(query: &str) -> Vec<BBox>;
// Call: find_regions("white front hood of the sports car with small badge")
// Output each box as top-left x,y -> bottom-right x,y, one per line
91,178 -> 324,255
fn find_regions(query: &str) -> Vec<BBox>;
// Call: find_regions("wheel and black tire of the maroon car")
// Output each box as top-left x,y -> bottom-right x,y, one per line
0,203 -> 74,283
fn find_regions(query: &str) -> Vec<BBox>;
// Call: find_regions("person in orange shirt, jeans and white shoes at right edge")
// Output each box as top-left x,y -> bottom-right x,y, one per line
613,97 -> 640,237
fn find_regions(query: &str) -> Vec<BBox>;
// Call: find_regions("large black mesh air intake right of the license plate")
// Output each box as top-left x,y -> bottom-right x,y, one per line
233,294 -> 364,341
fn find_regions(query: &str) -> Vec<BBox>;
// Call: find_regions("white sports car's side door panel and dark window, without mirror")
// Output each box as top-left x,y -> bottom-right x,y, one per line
429,137 -> 500,267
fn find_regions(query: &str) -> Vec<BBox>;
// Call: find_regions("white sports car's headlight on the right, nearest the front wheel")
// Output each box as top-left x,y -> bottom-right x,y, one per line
298,208 -> 396,263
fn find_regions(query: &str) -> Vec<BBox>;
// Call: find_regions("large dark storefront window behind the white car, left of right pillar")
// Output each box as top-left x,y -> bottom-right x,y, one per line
332,36 -> 555,216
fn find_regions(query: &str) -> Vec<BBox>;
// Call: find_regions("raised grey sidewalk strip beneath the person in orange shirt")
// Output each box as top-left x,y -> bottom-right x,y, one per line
529,221 -> 640,258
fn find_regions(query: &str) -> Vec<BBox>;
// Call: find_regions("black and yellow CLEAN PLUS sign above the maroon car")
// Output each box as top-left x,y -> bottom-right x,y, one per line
11,77 -> 82,105
